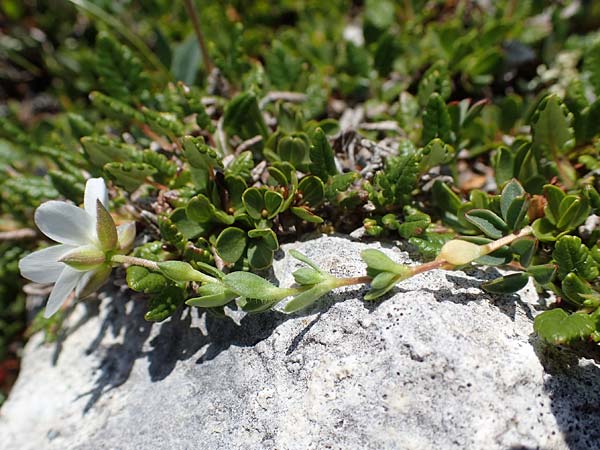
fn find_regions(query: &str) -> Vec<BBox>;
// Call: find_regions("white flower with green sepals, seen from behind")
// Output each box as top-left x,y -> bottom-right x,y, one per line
19,178 -> 135,318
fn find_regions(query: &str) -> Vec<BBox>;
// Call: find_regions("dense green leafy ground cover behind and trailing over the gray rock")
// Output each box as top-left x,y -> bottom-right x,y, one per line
0,0 -> 600,402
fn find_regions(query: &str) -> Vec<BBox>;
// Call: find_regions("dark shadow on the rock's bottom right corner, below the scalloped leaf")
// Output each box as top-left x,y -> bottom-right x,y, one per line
530,336 -> 600,450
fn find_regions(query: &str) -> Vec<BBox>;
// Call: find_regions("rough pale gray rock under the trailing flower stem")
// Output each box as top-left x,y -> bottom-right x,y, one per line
0,237 -> 600,450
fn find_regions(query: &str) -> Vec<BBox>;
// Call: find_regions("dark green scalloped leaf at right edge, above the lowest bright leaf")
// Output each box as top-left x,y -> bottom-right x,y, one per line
552,236 -> 598,280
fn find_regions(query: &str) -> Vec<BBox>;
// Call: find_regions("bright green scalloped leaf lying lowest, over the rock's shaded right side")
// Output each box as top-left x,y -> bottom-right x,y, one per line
533,308 -> 596,344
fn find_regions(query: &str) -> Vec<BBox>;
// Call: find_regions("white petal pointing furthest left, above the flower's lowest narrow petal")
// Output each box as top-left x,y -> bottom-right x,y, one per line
19,245 -> 75,283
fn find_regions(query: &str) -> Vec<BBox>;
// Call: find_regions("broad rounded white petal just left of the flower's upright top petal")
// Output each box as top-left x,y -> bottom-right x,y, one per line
34,200 -> 96,245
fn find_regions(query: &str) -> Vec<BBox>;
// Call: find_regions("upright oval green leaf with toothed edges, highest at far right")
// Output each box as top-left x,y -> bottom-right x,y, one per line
532,94 -> 575,155
